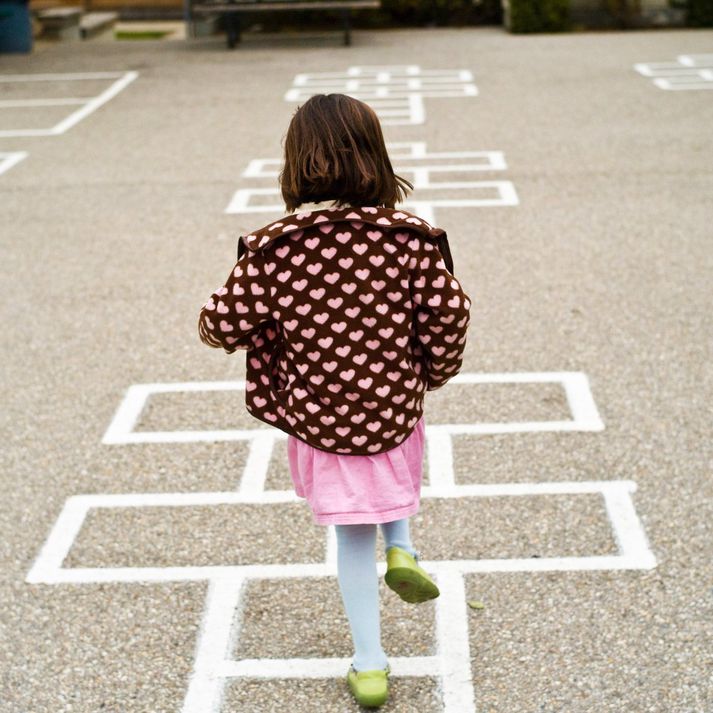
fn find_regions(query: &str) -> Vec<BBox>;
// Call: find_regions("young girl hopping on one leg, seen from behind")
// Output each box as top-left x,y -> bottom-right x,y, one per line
199,94 -> 470,706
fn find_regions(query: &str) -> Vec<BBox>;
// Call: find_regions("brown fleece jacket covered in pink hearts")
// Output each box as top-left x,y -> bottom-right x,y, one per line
198,206 -> 471,455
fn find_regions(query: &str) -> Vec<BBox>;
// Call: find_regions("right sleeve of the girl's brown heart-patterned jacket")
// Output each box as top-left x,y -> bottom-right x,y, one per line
410,234 -> 471,391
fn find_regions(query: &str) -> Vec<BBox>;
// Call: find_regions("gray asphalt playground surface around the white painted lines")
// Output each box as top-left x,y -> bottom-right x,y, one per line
0,28 -> 713,713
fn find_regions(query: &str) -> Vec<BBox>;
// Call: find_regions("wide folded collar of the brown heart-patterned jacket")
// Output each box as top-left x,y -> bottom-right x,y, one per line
240,206 -> 445,251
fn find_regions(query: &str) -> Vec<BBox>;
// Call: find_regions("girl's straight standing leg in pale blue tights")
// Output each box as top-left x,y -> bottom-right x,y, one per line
334,525 -> 388,671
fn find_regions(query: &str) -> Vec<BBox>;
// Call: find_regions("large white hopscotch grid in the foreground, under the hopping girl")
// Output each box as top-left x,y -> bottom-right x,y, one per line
27,362 -> 656,713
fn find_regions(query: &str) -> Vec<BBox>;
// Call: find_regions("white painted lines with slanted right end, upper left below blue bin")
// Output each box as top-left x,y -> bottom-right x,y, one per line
0,71 -> 139,138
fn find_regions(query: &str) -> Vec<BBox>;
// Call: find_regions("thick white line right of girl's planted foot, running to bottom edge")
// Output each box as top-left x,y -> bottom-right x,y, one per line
436,570 -> 475,713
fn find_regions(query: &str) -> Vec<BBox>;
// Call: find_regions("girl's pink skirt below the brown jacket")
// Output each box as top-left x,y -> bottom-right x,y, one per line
287,416 -> 426,525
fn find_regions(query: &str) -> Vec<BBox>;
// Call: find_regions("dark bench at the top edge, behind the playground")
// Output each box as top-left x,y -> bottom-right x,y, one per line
191,0 -> 381,49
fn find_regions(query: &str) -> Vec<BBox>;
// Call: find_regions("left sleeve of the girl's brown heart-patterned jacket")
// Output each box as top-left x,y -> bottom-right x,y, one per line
198,245 -> 273,354
